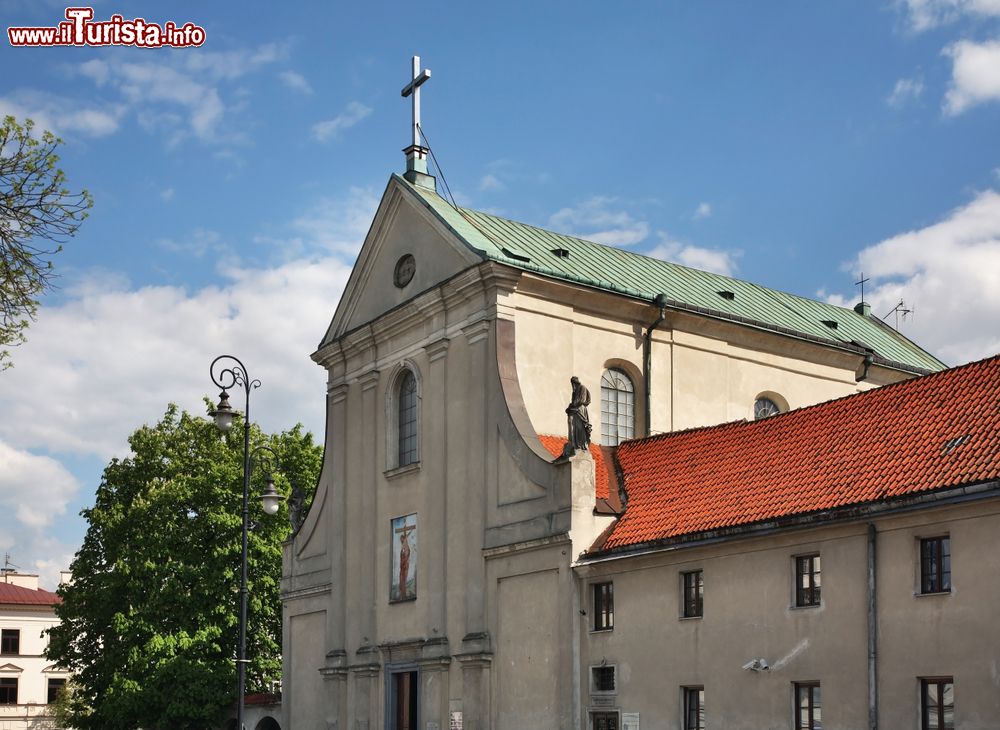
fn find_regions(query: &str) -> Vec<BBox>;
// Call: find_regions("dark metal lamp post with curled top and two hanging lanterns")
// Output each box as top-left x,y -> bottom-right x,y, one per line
209,355 -> 284,730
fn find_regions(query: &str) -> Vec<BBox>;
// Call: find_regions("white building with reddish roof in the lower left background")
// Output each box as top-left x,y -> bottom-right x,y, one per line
0,568 -> 69,730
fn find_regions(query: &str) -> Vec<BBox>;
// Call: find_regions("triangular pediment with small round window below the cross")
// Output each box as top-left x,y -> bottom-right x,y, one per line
320,176 -> 483,347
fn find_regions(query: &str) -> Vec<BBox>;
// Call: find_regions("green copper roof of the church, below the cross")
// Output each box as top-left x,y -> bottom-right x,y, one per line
394,176 -> 945,371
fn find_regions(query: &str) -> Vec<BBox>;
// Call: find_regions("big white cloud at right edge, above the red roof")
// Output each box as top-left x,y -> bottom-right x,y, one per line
830,190 -> 1000,365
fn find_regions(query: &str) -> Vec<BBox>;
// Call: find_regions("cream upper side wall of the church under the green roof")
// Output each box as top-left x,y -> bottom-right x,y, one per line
511,277 -> 912,442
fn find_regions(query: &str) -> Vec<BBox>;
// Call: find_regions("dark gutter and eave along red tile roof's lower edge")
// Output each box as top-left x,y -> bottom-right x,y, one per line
576,481 -> 1000,566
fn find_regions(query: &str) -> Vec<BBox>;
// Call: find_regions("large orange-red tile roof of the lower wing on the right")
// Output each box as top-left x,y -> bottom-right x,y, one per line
595,356 -> 1000,550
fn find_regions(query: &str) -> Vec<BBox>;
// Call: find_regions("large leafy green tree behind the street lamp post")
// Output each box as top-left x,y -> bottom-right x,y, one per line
46,406 -> 322,730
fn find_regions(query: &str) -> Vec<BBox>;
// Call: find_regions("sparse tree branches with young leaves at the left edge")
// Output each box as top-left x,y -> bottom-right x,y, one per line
0,116 -> 94,370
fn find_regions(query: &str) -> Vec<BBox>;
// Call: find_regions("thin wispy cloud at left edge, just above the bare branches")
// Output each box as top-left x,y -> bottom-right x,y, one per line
0,90 -> 125,137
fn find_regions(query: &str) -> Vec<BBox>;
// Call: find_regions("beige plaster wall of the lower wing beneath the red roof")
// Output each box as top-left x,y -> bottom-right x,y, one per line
578,500 -> 1000,730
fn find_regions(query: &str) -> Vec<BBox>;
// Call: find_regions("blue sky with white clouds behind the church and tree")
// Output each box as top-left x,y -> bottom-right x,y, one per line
0,0 -> 1000,586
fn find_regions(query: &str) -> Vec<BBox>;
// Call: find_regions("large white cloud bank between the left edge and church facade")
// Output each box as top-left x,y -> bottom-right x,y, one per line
0,189 -> 374,587
